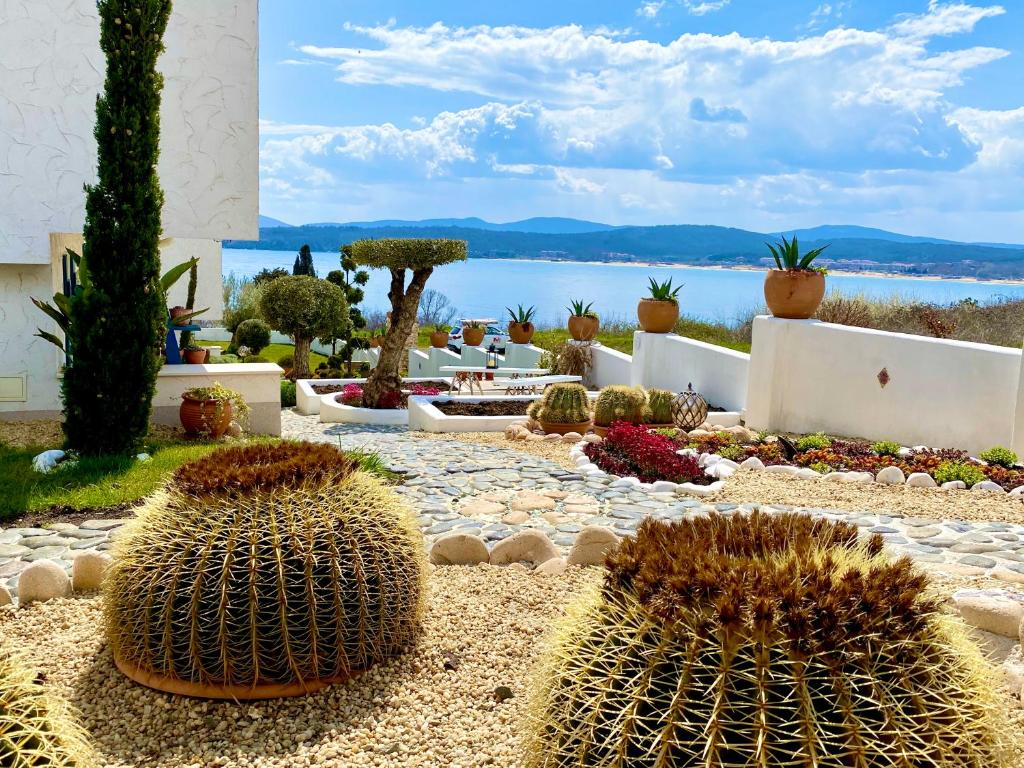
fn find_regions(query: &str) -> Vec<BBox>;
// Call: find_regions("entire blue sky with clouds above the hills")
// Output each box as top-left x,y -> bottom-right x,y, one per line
260,0 -> 1024,243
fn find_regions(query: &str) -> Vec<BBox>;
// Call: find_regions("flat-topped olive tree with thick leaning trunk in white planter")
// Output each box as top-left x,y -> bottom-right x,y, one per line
352,239 -> 467,408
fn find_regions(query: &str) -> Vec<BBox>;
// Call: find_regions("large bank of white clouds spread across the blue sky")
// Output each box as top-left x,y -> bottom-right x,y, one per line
261,2 -> 1024,240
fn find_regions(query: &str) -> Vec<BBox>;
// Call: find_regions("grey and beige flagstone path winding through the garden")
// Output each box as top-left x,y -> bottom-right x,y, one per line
0,411 -> 1024,592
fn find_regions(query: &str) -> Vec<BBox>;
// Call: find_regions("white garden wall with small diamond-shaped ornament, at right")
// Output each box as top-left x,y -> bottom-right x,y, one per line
746,316 -> 1021,453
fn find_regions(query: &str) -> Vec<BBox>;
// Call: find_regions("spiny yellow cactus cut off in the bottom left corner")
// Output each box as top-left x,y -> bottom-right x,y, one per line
0,648 -> 95,768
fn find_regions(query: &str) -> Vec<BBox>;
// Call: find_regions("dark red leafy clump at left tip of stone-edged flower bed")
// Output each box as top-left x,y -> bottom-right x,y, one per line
584,422 -> 712,485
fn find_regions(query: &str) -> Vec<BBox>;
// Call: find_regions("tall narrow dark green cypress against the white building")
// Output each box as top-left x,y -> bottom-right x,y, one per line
61,0 -> 171,455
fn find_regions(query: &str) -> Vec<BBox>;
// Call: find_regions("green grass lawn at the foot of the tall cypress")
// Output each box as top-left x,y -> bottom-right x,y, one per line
0,441 -> 217,520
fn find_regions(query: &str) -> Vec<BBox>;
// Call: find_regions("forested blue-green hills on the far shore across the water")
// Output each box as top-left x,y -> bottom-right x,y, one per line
224,219 -> 1024,279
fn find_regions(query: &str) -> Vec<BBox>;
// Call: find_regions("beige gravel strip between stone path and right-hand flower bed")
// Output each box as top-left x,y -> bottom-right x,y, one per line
706,471 -> 1024,525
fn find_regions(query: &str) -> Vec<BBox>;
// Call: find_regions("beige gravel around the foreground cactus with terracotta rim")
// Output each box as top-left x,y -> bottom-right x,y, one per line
0,566 -> 600,768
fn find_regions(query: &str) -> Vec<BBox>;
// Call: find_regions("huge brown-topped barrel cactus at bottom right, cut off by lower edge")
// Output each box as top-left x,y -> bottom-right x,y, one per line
526,514 -> 1006,768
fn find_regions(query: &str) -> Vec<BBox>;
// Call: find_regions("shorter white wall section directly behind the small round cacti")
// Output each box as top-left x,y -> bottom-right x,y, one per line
630,331 -> 751,411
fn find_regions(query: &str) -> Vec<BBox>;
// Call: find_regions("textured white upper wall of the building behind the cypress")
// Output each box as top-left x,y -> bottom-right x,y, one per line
0,0 -> 259,264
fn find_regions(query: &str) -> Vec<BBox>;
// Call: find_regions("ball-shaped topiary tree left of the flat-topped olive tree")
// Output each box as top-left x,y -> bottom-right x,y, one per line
259,276 -> 345,379
